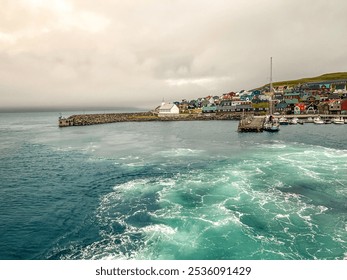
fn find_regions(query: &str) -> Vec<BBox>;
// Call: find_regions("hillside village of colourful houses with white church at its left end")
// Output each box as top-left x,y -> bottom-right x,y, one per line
158,79 -> 347,116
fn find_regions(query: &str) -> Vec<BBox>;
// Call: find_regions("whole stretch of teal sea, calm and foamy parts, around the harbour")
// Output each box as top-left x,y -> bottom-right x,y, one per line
0,113 -> 347,260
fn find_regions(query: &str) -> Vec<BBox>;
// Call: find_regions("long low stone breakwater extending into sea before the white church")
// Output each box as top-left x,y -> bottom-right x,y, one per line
59,112 -> 245,127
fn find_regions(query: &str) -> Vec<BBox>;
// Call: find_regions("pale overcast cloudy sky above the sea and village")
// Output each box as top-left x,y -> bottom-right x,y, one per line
0,0 -> 347,110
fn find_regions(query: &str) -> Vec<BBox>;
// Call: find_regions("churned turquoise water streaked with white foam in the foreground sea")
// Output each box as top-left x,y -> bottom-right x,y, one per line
55,144 -> 347,259
